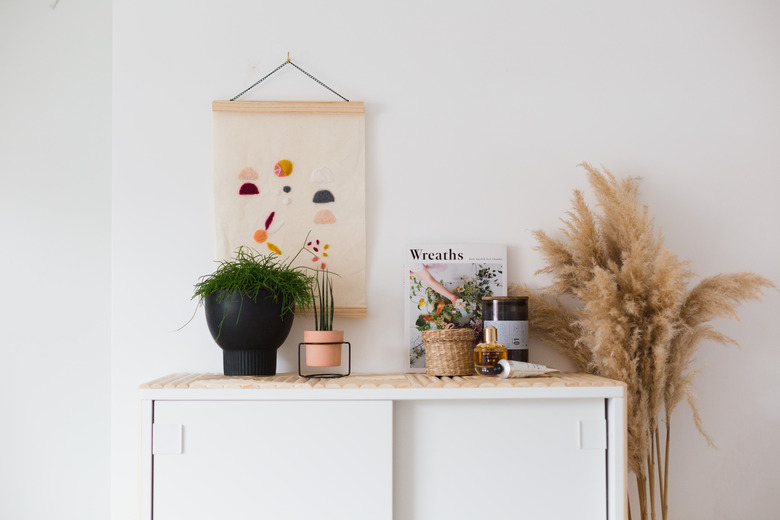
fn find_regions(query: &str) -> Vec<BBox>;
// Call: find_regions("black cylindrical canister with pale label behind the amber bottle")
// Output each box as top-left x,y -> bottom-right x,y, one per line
482,296 -> 528,362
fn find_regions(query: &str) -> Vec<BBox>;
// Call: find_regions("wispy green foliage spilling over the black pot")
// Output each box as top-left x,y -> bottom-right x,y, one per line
193,246 -> 314,315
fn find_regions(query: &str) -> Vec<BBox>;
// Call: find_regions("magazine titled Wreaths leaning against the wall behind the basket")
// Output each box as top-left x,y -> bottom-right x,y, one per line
404,244 -> 507,372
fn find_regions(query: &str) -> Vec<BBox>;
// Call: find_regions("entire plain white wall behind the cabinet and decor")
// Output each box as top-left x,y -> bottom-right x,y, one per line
0,0 -> 780,519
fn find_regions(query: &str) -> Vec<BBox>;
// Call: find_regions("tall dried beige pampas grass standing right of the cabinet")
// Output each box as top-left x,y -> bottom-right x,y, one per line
510,163 -> 775,519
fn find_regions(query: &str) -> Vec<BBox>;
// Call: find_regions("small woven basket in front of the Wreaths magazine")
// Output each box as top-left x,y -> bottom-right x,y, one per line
422,329 -> 476,376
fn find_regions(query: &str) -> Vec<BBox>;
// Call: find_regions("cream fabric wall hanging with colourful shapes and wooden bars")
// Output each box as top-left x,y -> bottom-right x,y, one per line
212,101 -> 366,317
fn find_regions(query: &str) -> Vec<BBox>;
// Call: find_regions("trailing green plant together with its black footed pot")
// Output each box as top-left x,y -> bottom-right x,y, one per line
193,247 -> 312,376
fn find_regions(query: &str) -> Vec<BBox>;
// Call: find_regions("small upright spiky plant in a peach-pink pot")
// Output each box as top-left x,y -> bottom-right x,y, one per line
303,263 -> 344,367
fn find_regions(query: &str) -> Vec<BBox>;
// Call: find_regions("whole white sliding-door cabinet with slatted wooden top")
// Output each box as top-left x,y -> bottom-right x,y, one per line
140,374 -> 625,520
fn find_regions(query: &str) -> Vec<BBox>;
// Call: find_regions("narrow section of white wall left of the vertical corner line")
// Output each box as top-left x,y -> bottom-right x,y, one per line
0,0 -> 111,520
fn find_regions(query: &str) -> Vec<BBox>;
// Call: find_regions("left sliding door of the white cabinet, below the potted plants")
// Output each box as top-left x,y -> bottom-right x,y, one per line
152,401 -> 392,520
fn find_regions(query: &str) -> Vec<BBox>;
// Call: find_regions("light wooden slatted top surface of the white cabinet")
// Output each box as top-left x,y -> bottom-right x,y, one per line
140,373 -> 623,389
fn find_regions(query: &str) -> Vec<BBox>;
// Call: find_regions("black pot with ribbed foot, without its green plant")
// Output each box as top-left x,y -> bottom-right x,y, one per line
203,291 -> 295,376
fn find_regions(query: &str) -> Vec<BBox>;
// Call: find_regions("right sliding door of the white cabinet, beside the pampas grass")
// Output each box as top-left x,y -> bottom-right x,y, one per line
394,399 -> 607,520
